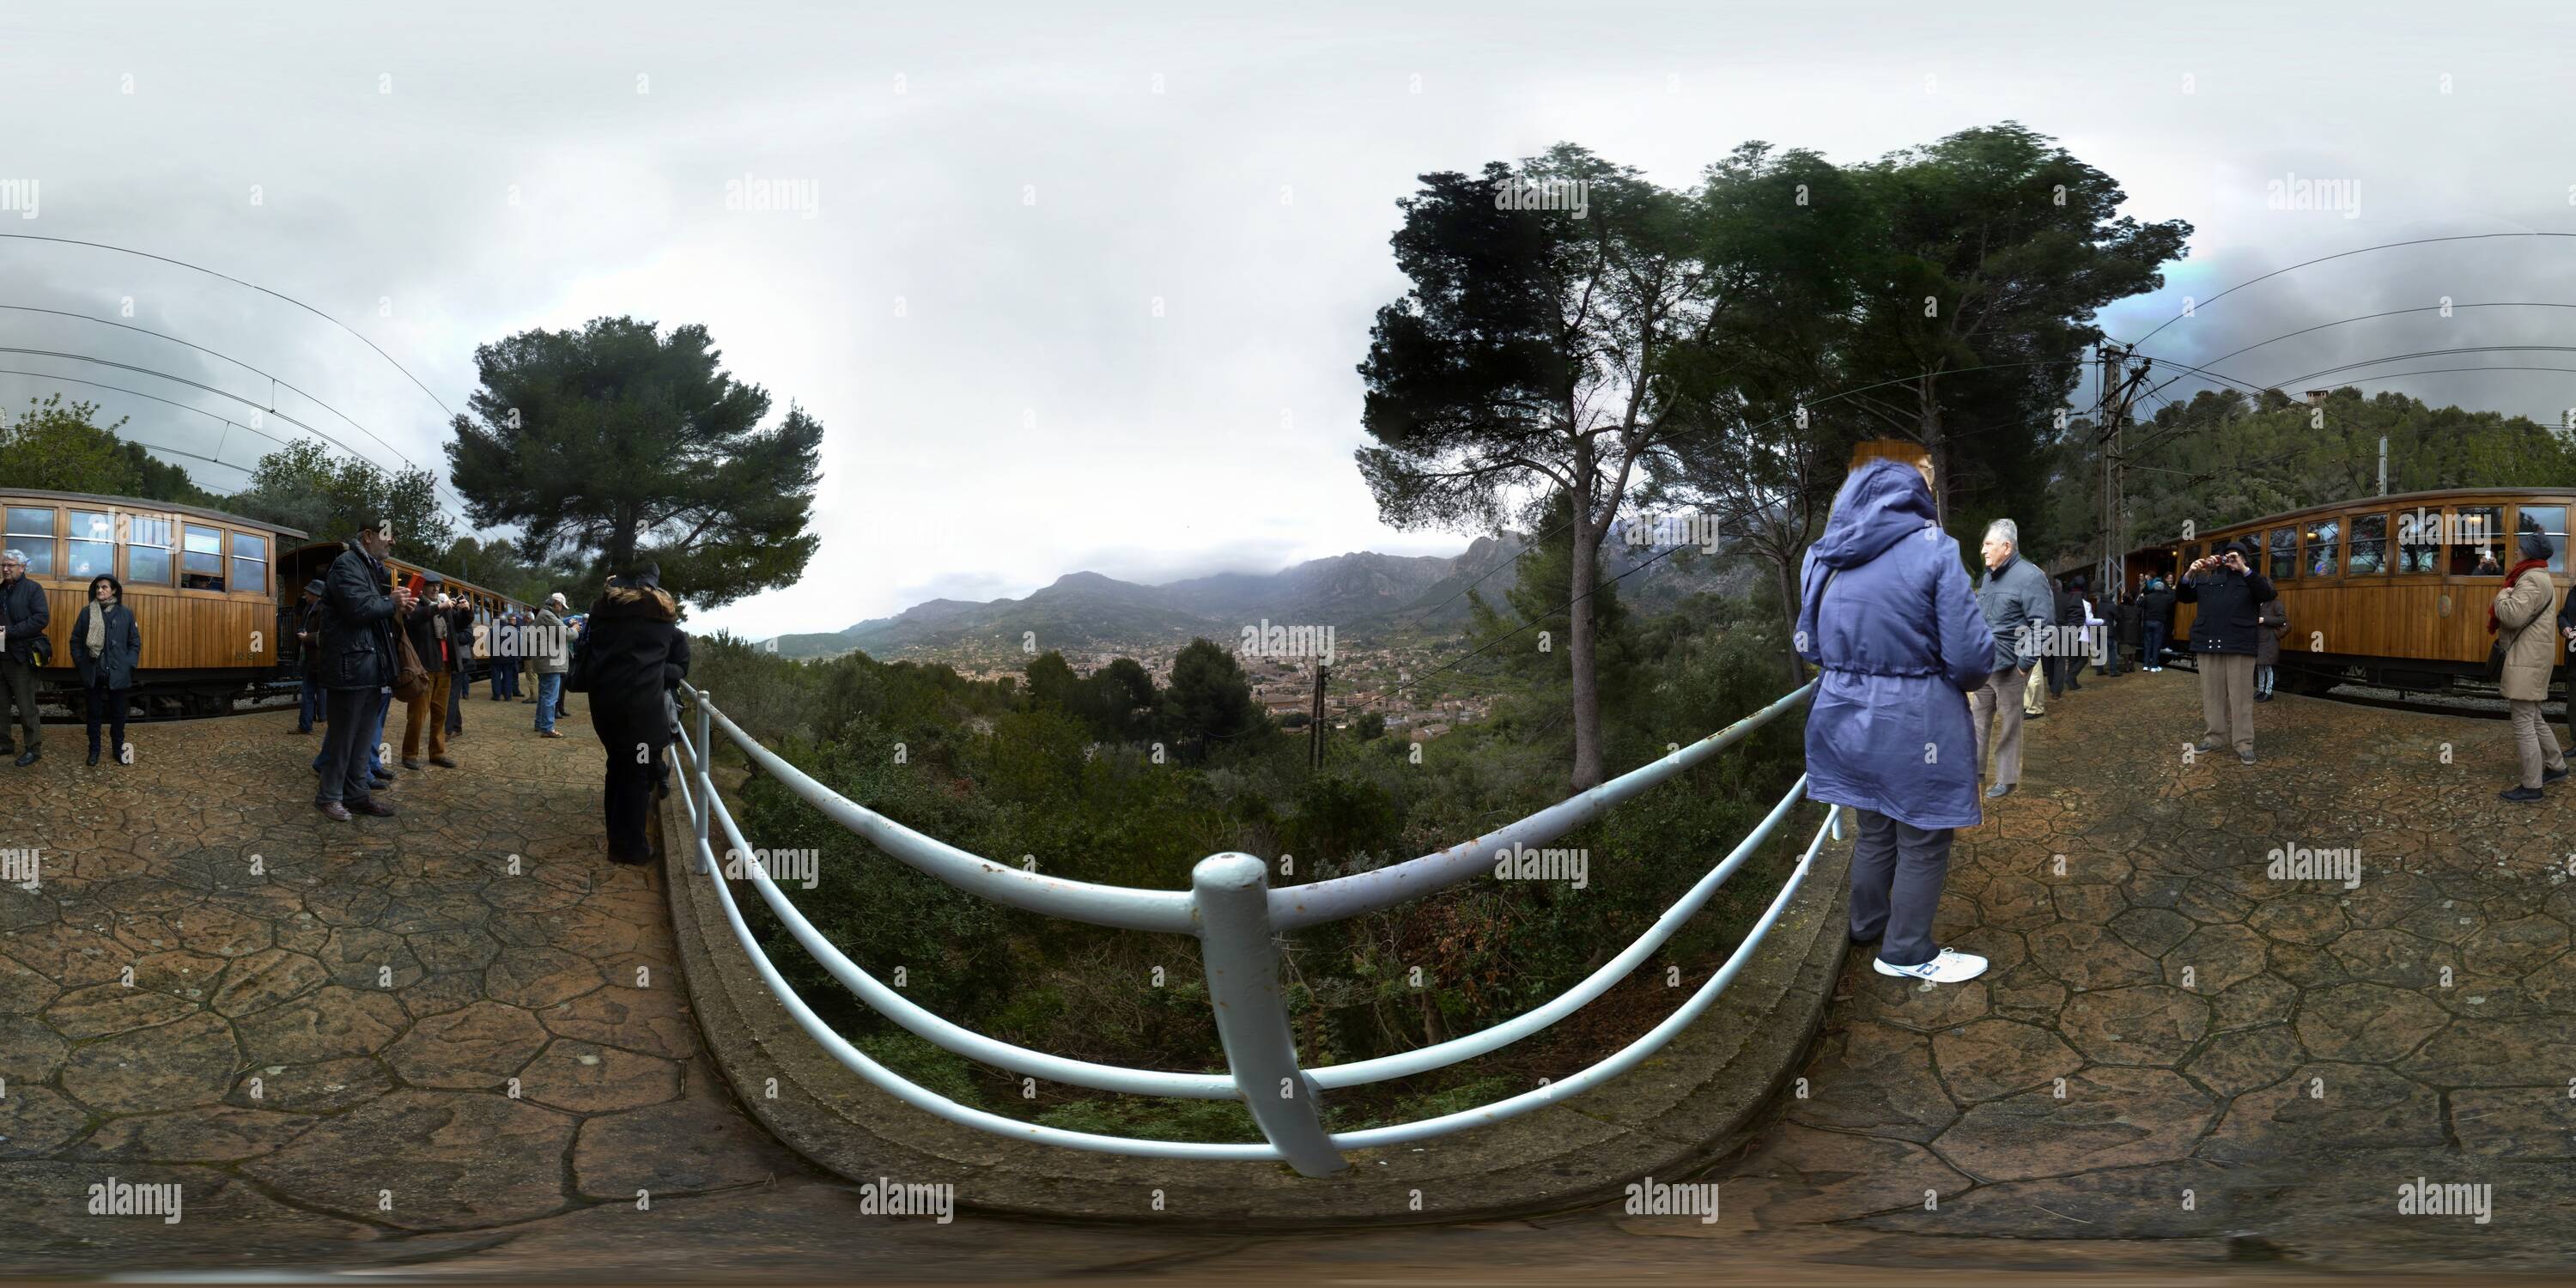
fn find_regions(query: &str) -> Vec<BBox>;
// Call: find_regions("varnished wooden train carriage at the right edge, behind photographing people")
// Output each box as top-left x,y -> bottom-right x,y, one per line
2130,487 -> 2576,693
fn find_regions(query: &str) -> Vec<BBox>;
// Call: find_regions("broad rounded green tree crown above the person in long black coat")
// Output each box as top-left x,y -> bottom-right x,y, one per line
448,317 -> 822,608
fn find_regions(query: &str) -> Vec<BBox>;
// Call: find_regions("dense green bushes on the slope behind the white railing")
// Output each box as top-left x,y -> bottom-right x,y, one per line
701,598 -> 1814,1141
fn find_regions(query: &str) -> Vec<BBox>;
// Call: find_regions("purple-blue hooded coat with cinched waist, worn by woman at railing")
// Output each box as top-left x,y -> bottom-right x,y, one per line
1798,459 -> 1996,829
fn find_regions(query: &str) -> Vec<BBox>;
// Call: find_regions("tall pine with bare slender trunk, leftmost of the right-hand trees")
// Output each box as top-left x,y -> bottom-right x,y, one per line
1358,144 -> 1723,791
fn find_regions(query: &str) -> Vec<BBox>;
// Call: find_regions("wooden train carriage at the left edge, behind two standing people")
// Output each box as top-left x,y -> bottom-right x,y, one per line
0,489 -> 304,706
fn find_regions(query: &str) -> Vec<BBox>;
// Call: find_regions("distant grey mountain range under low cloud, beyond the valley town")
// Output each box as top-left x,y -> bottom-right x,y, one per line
757,533 -> 1718,657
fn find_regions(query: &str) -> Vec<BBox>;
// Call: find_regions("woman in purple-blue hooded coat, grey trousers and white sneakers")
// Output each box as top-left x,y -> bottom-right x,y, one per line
1795,459 -> 1994,984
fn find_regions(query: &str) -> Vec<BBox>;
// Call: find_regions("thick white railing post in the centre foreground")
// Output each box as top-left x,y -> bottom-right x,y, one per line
1190,853 -> 1350,1177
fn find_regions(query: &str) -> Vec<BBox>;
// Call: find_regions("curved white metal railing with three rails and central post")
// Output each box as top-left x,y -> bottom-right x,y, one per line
677,683 -> 1842,1177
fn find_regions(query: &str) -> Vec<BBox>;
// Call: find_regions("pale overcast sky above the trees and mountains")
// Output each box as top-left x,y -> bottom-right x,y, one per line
0,0 -> 2576,636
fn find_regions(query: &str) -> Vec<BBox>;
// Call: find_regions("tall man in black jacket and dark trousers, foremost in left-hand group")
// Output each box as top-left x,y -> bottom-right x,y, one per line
314,520 -> 412,822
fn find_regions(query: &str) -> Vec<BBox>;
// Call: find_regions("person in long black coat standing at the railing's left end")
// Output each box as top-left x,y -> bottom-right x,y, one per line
572,564 -> 688,863
